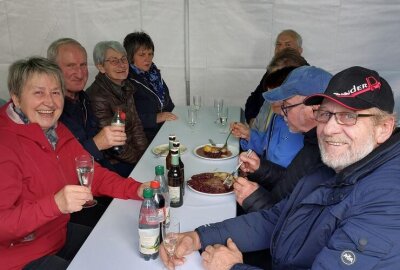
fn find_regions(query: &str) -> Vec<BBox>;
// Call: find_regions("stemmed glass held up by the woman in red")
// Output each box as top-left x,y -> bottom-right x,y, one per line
75,154 -> 97,208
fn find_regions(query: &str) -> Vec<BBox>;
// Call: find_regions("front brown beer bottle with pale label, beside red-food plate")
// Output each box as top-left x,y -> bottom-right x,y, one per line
168,148 -> 183,207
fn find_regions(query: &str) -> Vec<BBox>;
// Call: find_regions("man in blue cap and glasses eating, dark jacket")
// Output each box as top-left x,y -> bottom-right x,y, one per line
234,66 -> 332,212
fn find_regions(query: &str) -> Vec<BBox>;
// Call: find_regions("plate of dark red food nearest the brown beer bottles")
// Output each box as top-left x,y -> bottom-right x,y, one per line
187,172 -> 233,196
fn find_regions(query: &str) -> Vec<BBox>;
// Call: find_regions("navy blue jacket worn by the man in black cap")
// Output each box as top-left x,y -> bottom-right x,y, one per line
197,130 -> 400,270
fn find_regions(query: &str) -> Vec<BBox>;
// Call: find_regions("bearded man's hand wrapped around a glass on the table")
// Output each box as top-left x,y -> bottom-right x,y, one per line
160,232 -> 201,270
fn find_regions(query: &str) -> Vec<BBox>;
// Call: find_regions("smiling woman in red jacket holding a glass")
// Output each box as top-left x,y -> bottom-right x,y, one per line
0,57 -> 146,269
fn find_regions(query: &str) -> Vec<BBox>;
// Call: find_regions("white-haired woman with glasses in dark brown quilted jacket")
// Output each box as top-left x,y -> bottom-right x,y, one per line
86,41 -> 148,177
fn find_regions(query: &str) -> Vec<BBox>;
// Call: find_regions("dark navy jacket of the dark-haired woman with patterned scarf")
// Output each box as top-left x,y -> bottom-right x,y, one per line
128,70 -> 175,143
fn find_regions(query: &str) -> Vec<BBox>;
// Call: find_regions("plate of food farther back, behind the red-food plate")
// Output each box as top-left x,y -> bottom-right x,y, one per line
193,143 -> 239,160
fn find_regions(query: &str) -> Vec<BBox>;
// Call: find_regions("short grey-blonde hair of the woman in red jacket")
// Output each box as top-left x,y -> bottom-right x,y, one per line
7,56 -> 65,98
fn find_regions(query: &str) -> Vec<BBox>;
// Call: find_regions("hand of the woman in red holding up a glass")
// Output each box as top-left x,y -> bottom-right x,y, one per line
54,185 -> 93,214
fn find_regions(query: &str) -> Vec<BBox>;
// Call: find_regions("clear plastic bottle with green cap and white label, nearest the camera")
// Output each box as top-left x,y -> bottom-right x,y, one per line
139,188 -> 160,261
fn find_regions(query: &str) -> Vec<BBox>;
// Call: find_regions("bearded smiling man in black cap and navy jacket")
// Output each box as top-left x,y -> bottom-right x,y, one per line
160,67 -> 400,270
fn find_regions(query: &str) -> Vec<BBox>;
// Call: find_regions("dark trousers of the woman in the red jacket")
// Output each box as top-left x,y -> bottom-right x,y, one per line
23,222 -> 92,270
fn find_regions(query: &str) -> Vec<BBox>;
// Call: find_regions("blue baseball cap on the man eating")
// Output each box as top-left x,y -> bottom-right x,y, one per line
263,66 -> 332,102
